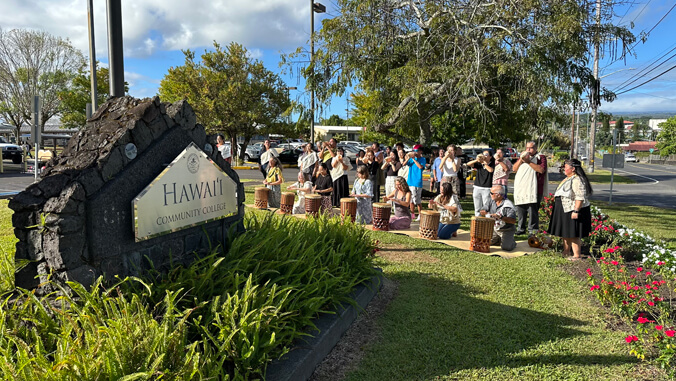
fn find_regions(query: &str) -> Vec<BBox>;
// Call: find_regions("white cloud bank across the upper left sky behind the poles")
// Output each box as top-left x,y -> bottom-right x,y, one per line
0,0 -> 312,58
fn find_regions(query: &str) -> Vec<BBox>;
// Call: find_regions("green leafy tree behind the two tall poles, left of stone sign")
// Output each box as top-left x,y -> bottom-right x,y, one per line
59,67 -> 129,128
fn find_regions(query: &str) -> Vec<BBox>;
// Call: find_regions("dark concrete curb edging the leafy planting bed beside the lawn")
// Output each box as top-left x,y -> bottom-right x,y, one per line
265,269 -> 383,381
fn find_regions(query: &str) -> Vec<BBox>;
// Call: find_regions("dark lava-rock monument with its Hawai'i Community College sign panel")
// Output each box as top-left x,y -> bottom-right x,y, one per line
9,97 -> 244,291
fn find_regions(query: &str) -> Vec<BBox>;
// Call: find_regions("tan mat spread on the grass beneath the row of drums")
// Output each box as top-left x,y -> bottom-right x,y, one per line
246,205 -> 541,258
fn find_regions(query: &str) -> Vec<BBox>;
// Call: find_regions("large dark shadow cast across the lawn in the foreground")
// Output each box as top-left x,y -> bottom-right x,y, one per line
351,272 -> 637,380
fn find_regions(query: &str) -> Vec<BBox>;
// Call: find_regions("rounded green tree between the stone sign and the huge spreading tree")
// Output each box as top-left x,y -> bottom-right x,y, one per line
159,42 -> 290,158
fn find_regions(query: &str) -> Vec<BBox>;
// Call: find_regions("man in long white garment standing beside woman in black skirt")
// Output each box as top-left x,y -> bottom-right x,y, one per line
513,141 -> 547,234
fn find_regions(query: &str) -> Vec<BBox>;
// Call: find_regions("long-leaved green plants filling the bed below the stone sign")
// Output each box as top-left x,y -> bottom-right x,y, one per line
0,213 -> 376,380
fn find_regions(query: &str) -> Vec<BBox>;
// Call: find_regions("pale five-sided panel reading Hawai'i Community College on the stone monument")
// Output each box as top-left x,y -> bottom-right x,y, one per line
132,143 -> 237,242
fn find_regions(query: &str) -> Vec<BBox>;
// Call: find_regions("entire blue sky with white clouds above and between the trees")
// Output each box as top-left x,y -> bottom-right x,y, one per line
0,0 -> 676,117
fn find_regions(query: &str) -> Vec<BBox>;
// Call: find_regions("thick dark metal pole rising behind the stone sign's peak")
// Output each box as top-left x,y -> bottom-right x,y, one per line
107,0 -> 124,98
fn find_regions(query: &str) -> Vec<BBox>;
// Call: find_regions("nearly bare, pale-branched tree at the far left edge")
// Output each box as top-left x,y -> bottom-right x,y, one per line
0,29 -> 85,136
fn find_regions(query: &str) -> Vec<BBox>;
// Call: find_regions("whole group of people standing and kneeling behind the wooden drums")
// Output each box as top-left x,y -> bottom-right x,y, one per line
250,138 -> 592,258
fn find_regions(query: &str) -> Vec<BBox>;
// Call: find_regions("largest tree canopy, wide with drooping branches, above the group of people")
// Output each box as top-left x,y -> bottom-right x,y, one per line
296,0 -> 634,143
